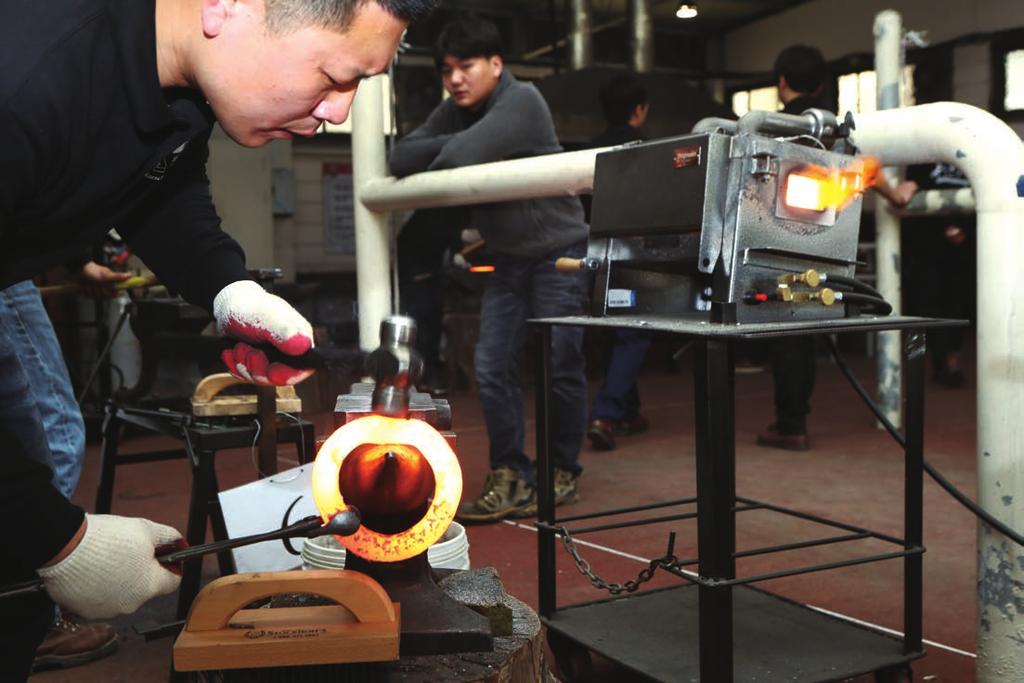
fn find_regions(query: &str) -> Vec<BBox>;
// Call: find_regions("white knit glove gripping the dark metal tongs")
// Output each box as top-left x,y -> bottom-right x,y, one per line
36,514 -> 181,618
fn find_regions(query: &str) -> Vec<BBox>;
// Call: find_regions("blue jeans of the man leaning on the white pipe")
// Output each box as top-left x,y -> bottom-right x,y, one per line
475,243 -> 587,481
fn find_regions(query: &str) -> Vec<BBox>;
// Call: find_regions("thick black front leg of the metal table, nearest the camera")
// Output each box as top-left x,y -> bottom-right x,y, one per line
693,339 -> 736,683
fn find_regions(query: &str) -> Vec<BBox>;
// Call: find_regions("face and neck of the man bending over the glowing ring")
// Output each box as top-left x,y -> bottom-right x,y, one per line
196,0 -> 406,146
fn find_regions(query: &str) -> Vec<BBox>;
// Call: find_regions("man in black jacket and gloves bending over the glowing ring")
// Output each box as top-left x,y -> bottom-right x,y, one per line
0,0 -> 436,681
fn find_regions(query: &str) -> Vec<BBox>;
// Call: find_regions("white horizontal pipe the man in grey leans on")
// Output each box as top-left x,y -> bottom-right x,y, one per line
359,147 -> 613,211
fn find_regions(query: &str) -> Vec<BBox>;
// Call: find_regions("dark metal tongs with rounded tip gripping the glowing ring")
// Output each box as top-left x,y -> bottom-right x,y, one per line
0,506 -> 362,600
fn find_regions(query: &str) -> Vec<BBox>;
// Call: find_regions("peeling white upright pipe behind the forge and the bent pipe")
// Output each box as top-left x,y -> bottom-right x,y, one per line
874,9 -> 903,428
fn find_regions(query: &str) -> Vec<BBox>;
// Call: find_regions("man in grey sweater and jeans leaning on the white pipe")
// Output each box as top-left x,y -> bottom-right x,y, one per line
391,17 -> 588,522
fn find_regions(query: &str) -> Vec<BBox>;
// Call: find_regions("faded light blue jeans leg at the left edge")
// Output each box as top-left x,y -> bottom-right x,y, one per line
0,281 -> 85,499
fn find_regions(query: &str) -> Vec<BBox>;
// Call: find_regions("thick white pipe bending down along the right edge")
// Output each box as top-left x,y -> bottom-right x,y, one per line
851,102 -> 1024,683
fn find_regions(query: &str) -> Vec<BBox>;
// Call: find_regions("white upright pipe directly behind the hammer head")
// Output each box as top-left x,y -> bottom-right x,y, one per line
352,76 -> 391,350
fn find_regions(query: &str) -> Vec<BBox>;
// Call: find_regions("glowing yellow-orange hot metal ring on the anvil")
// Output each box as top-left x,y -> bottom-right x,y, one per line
312,415 -> 462,562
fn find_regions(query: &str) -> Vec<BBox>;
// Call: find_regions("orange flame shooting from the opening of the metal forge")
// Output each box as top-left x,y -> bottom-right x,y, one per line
782,157 -> 882,212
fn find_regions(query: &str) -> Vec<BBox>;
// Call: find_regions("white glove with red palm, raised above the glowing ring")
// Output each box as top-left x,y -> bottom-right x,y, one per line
213,280 -> 313,385
